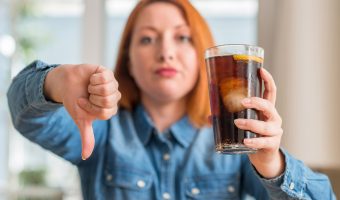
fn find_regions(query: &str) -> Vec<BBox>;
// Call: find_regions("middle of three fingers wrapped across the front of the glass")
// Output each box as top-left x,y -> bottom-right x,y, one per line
234,119 -> 283,136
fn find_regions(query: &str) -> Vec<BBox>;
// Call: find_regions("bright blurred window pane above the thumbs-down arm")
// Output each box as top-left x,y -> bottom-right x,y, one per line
12,0 -> 84,76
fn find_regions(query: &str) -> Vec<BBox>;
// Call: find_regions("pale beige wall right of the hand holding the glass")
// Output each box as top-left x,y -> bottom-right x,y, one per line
259,0 -> 340,168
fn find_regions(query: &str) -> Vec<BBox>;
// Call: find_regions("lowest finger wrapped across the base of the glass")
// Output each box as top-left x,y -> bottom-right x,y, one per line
243,137 -> 280,149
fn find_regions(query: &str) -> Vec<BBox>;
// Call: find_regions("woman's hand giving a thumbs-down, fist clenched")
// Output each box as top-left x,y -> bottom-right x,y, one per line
44,64 -> 121,160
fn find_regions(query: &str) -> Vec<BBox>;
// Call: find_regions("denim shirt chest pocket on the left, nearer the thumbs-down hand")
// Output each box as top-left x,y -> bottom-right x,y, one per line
105,167 -> 152,199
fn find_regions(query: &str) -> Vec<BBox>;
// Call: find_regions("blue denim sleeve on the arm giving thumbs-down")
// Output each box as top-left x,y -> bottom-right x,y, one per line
7,61 -> 105,164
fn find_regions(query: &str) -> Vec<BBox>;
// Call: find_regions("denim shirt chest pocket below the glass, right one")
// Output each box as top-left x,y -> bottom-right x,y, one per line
185,174 -> 240,200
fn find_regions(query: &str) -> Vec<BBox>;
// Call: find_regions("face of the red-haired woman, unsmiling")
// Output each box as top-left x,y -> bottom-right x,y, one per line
129,2 -> 199,104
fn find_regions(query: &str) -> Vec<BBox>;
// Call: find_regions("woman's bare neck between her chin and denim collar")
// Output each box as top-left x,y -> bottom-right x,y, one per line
142,98 -> 186,133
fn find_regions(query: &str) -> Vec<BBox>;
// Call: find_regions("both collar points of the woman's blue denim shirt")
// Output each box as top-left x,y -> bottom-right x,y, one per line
134,105 -> 197,147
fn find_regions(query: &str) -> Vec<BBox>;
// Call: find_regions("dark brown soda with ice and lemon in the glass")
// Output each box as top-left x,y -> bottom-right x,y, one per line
206,55 -> 263,153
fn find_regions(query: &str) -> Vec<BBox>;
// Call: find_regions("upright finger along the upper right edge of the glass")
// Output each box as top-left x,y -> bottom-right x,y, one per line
260,68 -> 276,105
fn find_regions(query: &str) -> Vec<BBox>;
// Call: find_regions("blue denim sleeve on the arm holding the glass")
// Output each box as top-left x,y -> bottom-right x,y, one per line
258,149 -> 336,200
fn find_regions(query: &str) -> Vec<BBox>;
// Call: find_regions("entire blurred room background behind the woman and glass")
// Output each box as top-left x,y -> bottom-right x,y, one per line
0,0 -> 340,200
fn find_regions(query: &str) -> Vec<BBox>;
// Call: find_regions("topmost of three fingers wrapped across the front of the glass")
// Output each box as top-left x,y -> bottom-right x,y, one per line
242,97 -> 281,124
